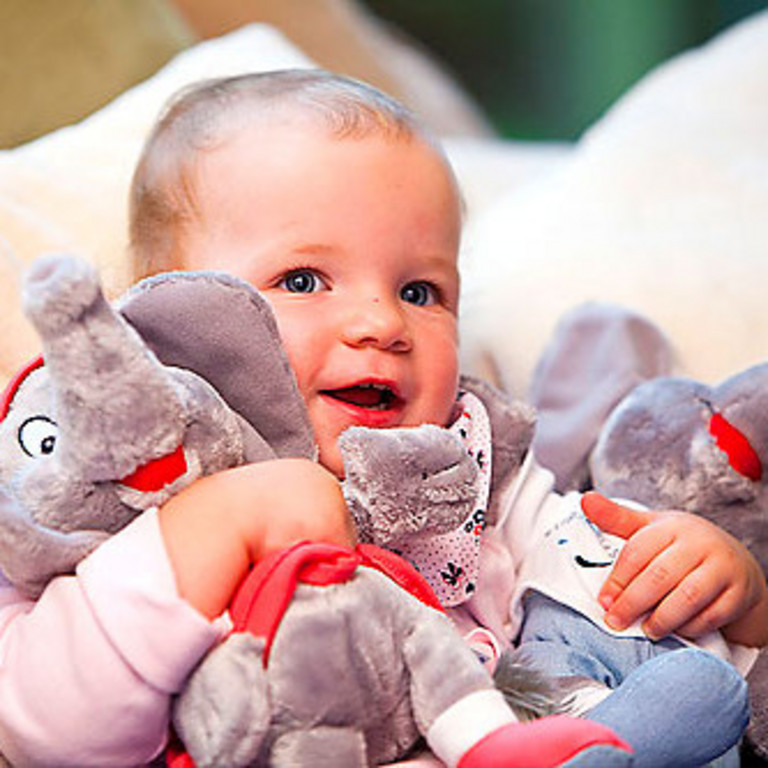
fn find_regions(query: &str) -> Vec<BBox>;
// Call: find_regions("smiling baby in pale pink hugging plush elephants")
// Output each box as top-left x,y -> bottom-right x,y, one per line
0,71 -> 768,765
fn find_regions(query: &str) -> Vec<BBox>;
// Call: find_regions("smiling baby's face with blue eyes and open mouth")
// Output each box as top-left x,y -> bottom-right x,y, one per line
183,119 -> 461,476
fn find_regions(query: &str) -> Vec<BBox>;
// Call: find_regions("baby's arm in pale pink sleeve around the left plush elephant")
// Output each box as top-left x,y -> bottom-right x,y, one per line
0,460 -> 351,766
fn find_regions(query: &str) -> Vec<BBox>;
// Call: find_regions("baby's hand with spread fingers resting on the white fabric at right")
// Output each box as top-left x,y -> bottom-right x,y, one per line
582,493 -> 768,646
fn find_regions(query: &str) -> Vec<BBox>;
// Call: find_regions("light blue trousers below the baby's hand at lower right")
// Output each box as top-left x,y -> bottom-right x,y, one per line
518,593 -> 749,768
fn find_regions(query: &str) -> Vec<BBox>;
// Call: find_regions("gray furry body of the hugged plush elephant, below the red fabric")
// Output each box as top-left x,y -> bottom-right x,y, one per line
175,547 -> 500,768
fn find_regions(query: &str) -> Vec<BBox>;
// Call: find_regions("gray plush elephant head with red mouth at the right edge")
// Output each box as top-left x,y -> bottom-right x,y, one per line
589,363 -> 768,765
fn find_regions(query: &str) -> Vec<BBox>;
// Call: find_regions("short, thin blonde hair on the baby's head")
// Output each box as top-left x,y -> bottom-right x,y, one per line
129,69 -> 450,280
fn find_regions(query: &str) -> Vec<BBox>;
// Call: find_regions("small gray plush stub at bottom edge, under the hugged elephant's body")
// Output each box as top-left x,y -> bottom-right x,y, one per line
269,726 -> 368,768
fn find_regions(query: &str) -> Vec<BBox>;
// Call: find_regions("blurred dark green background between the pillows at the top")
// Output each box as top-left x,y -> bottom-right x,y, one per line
365,0 -> 768,140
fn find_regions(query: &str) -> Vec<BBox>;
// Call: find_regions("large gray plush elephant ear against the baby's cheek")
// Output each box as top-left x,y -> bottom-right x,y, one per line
119,272 -> 315,458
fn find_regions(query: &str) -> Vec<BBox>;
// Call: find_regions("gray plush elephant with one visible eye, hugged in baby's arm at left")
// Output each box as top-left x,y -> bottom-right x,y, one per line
0,257 -> 628,768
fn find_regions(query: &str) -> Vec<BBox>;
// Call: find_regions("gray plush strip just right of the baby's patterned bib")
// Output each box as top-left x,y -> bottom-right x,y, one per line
459,376 -> 536,523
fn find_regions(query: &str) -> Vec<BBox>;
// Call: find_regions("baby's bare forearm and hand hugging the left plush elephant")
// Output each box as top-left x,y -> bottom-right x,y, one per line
159,459 -> 354,618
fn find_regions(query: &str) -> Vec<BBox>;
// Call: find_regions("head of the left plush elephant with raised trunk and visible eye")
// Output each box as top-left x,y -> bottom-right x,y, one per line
0,256 -> 313,596
